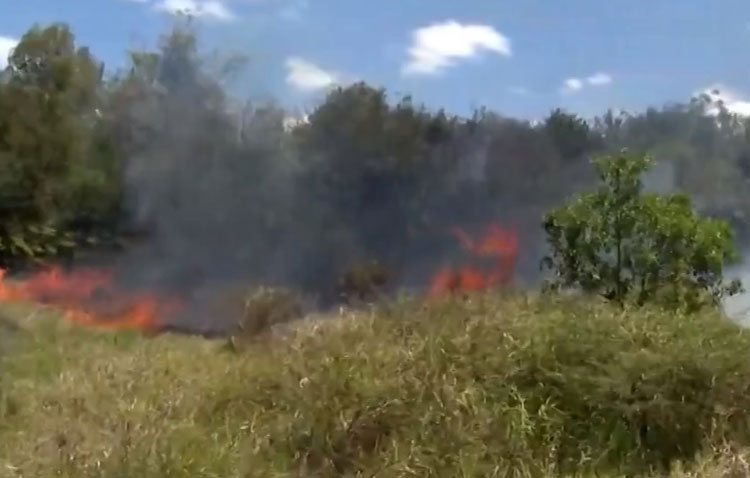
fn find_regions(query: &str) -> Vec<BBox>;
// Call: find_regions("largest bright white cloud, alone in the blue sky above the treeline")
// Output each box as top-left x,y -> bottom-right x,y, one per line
402,20 -> 512,75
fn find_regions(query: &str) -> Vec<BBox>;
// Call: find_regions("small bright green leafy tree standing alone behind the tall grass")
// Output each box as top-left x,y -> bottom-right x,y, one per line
542,151 -> 742,311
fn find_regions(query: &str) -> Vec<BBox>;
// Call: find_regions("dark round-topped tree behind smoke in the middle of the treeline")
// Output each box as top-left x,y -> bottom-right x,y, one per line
294,83 -> 456,282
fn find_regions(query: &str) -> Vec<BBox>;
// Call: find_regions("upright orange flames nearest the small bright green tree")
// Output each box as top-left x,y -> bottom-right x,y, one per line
428,223 -> 518,299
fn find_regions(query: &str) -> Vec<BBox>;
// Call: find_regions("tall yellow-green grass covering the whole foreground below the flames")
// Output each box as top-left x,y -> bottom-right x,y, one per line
0,294 -> 750,478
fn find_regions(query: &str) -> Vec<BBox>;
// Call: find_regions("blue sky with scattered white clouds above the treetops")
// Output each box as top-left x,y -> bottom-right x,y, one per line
0,0 -> 750,118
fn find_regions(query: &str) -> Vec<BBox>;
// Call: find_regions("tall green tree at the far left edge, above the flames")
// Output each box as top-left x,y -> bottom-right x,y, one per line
0,24 -> 118,267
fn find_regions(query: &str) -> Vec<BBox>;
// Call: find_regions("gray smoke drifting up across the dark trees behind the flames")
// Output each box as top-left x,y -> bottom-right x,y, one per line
73,29 -> 590,330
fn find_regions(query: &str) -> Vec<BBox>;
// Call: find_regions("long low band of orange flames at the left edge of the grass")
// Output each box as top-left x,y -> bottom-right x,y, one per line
0,267 -> 179,332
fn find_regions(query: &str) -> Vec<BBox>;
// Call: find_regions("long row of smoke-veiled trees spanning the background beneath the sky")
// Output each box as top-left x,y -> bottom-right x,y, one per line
0,21 -> 750,294
